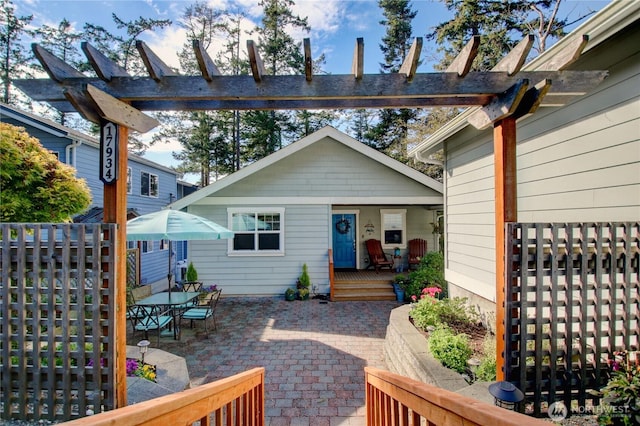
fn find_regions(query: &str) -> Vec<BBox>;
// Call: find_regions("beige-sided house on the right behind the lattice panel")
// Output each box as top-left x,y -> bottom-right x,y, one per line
410,1 -> 640,311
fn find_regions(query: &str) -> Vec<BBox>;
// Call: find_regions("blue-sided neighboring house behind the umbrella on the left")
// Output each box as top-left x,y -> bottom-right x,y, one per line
0,103 -> 194,288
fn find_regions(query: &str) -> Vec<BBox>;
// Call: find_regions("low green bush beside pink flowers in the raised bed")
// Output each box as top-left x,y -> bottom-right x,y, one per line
409,296 -> 478,330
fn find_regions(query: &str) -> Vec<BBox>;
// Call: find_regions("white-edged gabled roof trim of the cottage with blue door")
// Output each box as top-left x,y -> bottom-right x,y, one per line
169,126 -> 443,209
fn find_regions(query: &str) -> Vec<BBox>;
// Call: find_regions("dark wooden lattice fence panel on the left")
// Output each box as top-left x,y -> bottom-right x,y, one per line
0,223 -> 116,421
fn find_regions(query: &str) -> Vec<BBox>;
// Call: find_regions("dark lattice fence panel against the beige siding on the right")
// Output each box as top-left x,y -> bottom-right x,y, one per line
505,223 -> 640,415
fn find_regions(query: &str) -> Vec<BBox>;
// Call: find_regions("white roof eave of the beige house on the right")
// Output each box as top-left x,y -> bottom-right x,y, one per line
409,0 -> 640,161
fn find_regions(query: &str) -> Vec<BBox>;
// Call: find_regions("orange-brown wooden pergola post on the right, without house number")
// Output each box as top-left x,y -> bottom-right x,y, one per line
493,117 -> 518,381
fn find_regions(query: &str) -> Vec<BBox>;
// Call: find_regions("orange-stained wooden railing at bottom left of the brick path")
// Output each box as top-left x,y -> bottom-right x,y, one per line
64,368 -> 264,426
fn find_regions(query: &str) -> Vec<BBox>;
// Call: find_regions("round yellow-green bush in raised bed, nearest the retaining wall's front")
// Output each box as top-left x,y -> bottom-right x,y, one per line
428,327 -> 473,373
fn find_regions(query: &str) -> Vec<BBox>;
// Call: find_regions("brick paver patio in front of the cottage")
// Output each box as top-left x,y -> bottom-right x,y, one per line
130,298 -> 398,426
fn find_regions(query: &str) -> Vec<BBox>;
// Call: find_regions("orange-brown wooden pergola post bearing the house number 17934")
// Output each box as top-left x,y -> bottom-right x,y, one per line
100,121 -> 129,408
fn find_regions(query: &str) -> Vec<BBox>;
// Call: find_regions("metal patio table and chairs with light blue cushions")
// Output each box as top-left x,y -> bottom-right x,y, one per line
126,282 -> 222,345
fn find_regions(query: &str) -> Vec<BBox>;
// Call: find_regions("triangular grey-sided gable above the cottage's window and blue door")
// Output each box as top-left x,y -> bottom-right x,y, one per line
214,137 -> 441,198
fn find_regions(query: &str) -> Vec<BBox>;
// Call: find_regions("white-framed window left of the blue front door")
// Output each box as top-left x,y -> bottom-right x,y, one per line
228,208 -> 284,255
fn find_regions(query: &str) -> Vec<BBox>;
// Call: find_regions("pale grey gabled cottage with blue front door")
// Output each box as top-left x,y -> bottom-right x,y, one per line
170,127 -> 442,295
